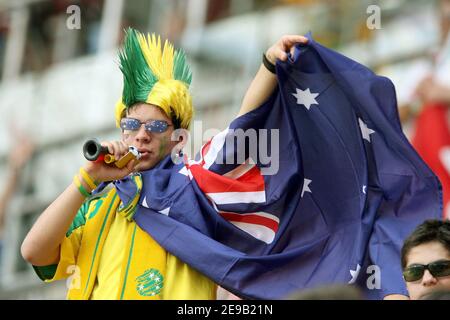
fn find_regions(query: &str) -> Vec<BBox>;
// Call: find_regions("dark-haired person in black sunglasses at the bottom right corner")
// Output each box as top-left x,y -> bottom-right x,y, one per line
401,220 -> 450,300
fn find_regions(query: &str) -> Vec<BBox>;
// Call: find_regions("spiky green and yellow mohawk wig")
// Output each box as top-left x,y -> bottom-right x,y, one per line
115,28 -> 193,129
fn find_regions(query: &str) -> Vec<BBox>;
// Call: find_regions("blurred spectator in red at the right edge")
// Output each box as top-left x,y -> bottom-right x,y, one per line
412,0 -> 450,217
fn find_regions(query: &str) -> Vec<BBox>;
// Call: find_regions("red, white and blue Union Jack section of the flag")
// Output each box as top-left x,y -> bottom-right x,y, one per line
181,130 -> 280,244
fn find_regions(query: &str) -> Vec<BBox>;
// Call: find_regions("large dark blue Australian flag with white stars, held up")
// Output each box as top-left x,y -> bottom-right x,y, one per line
130,37 -> 442,299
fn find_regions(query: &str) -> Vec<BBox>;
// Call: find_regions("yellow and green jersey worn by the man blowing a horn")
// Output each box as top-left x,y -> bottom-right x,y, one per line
34,188 -> 217,300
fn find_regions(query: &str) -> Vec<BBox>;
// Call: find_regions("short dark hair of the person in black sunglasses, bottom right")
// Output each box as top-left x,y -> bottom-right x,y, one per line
401,220 -> 450,269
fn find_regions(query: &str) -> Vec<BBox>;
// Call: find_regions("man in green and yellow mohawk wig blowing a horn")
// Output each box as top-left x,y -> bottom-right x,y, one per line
21,28 -> 307,299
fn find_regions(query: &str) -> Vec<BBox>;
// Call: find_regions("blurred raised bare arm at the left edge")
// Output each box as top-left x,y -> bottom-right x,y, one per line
0,129 -> 34,259
